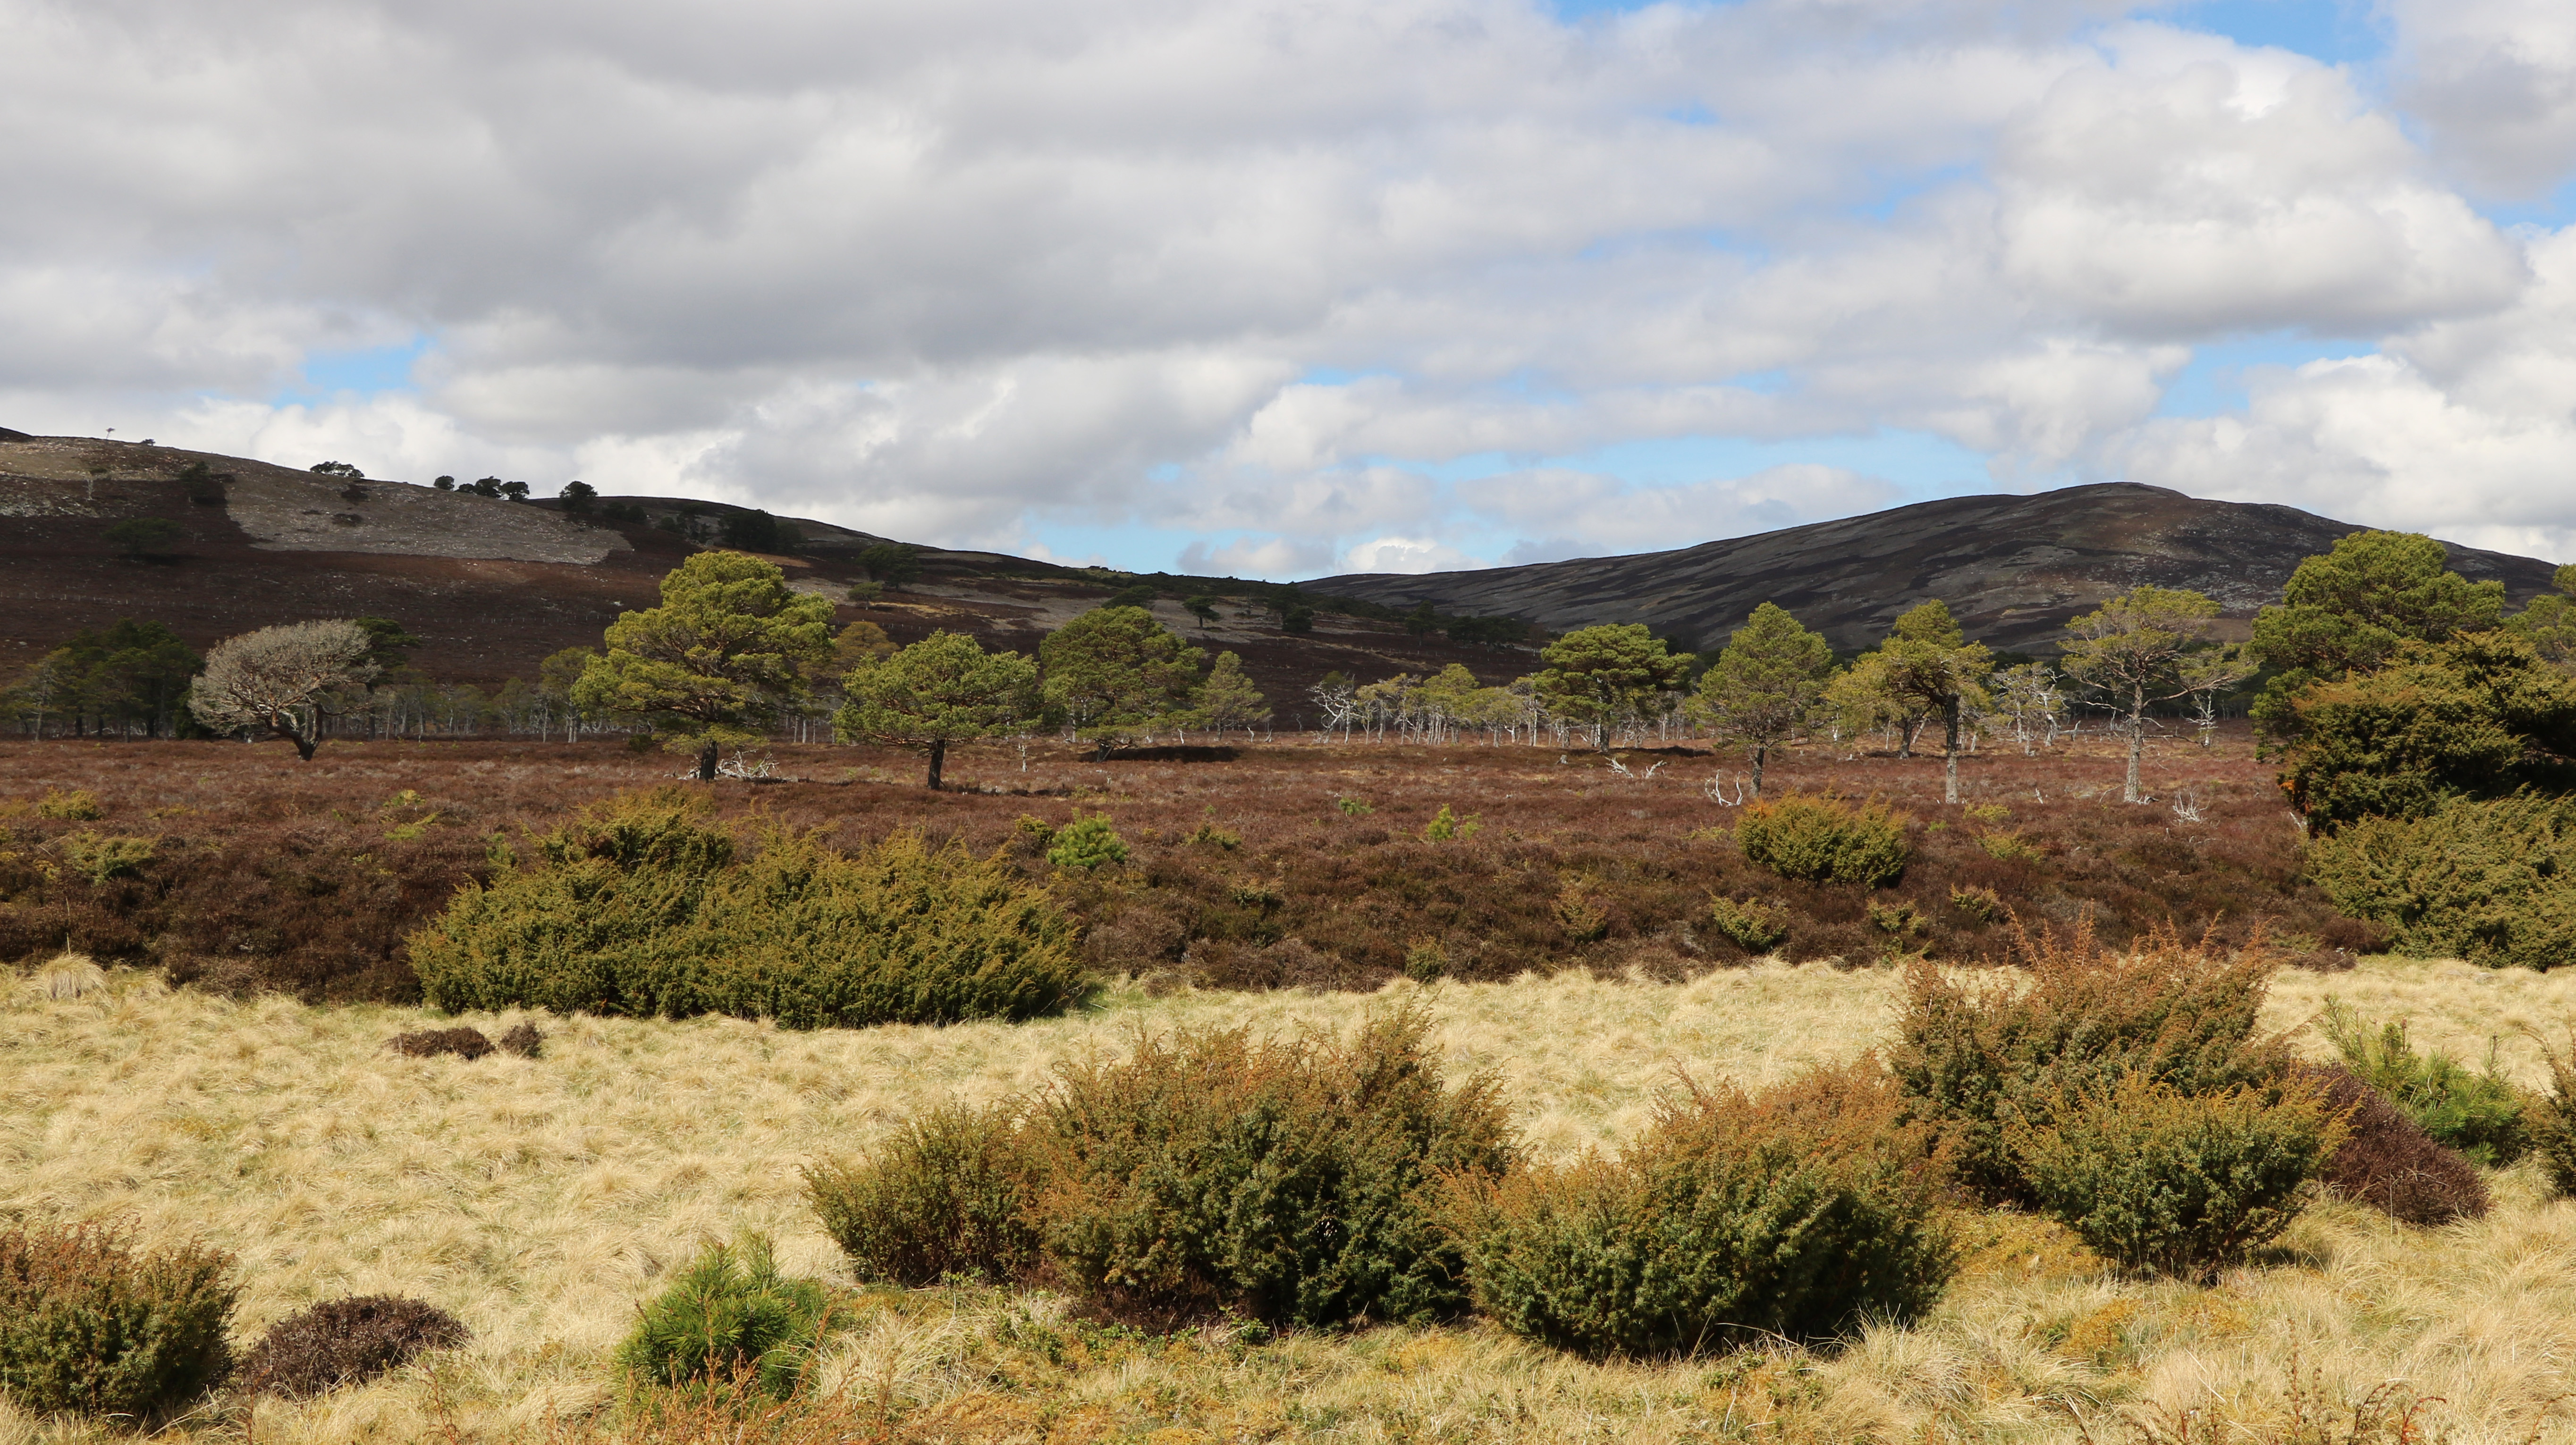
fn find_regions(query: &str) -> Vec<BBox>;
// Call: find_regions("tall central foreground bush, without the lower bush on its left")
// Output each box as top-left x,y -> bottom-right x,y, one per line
1028,1010 -> 1512,1324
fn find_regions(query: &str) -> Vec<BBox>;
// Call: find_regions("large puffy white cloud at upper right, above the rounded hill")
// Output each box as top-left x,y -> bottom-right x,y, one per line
1999,26 -> 2522,337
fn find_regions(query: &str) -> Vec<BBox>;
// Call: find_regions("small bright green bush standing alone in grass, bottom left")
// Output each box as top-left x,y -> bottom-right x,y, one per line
618,1234 -> 832,1399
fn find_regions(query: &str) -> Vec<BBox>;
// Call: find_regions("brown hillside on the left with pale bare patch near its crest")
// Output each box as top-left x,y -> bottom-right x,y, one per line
0,430 -> 1494,726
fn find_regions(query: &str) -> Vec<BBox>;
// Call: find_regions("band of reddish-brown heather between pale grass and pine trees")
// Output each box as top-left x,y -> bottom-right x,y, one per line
0,731 -> 2378,1002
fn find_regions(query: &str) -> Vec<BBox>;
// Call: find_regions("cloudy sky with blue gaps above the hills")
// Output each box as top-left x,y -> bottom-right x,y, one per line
0,0 -> 2576,580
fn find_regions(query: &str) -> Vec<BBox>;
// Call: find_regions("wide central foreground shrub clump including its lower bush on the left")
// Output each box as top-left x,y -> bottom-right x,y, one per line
806,1010 -> 1512,1327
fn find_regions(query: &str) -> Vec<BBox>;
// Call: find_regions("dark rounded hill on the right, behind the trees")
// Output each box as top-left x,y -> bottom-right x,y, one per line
1306,482 -> 2553,652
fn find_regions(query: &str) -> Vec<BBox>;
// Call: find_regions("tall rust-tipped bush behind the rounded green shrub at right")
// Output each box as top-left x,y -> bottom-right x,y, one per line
1888,920 -> 2288,1203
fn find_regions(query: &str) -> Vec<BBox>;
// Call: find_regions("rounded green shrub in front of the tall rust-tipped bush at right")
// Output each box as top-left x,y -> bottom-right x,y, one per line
2009,1072 -> 2344,1280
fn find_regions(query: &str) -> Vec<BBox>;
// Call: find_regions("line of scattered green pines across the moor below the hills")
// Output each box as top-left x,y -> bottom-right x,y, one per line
8,533 -> 2576,801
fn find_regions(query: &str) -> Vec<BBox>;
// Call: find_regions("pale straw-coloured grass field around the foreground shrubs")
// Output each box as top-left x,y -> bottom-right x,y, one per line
0,961 -> 2576,1445
